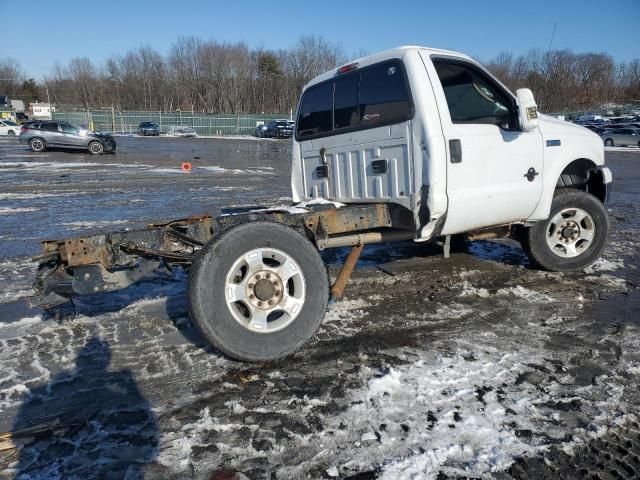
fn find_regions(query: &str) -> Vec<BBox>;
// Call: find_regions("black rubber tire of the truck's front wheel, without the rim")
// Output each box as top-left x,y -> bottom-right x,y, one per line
522,188 -> 610,272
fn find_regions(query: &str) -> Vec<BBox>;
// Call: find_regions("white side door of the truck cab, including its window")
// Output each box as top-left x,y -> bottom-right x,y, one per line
427,57 -> 544,234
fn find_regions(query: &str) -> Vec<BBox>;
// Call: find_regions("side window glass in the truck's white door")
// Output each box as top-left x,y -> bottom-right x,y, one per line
433,58 -> 518,130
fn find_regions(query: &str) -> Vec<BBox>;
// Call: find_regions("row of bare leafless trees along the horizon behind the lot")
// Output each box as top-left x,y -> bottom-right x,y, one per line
12,35 -> 640,113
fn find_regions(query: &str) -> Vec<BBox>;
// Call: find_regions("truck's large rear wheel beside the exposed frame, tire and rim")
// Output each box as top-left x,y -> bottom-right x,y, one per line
188,222 -> 329,361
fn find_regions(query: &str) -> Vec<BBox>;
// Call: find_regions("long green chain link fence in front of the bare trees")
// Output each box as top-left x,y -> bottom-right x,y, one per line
53,109 -> 291,135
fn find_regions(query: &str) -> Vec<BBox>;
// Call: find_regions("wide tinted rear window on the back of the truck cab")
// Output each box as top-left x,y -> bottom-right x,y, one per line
296,59 -> 414,141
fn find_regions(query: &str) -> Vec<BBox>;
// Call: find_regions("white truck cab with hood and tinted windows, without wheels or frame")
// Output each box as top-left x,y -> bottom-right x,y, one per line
292,46 -> 611,262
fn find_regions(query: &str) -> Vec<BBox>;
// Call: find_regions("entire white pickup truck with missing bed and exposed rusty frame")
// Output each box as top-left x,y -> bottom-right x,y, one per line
32,47 -> 611,361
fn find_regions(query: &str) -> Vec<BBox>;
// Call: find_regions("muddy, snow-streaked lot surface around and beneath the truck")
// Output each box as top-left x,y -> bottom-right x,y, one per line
0,138 -> 640,479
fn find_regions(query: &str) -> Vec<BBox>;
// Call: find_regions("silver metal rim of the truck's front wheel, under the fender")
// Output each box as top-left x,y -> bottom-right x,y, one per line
547,208 -> 596,258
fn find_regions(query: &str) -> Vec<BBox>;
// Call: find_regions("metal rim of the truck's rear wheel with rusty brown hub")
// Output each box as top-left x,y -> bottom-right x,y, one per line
224,248 -> 306,333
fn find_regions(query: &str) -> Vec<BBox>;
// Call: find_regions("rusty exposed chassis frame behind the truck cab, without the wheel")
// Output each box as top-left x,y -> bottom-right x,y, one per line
29,203 -> 415,308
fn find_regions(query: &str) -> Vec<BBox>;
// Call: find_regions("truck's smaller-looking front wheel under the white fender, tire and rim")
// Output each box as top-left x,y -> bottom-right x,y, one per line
523,189 -> 609,272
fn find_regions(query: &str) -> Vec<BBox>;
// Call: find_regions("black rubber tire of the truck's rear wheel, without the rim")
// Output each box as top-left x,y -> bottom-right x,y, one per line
188,222 -> 329,362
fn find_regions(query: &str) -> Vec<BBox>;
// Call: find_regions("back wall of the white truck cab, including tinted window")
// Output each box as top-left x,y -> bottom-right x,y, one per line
294,59 -> 413,206
